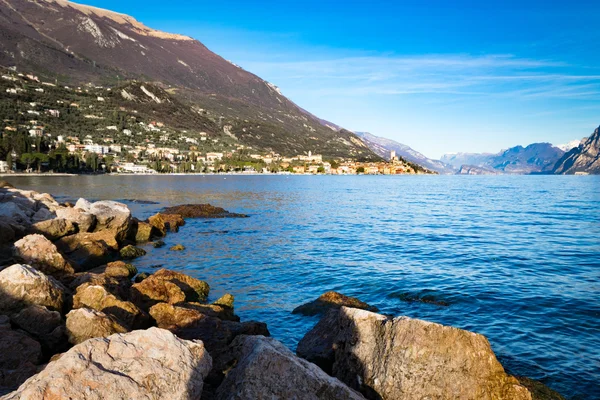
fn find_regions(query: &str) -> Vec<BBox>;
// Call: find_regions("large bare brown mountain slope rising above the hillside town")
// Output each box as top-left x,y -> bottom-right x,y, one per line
0,0 -> 379,160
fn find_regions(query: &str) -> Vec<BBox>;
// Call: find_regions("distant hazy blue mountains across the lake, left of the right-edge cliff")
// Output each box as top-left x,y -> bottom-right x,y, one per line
442,143 -> 565,174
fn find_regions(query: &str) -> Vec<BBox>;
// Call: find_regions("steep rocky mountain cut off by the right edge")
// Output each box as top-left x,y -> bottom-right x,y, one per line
553,127 -> 600,175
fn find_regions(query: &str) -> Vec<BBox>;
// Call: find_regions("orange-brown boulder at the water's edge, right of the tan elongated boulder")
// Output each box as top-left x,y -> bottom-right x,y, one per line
131,269 -> 210,309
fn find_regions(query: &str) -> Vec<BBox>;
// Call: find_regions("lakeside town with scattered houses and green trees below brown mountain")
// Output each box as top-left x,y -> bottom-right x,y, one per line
0,69 -> 432,175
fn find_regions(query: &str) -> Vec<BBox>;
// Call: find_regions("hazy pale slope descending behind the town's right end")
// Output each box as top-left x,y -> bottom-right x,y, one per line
355,132 -> 456,174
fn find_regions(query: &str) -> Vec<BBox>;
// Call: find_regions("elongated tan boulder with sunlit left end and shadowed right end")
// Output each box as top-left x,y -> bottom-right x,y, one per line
73,284 -> 149,329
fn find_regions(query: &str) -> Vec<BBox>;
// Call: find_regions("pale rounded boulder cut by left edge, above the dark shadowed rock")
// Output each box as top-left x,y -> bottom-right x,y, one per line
0,264 -> 66,313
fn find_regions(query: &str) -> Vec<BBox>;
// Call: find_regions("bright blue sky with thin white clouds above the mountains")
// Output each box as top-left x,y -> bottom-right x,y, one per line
79,0 -> 600,158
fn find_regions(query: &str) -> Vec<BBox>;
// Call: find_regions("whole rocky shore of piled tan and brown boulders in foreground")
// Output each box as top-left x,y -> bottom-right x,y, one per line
0,182 -> 561,400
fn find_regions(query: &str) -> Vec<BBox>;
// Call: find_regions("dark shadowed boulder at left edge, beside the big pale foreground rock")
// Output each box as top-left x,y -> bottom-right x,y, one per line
0,324 -> 42,390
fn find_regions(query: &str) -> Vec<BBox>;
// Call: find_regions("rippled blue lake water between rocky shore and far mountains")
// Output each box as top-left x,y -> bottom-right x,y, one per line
9,176 -> 600,399
